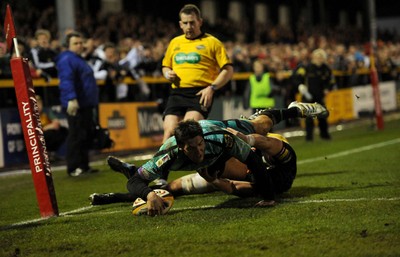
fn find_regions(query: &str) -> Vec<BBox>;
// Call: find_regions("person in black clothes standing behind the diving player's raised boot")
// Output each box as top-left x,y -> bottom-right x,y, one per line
294,48 -> 334,141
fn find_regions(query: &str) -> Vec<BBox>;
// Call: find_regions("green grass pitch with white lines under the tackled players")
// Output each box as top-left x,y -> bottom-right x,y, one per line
0,117 -> 400,256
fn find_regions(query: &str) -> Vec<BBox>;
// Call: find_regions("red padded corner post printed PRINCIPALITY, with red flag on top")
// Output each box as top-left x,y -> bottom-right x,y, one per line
4,5 -> 59,217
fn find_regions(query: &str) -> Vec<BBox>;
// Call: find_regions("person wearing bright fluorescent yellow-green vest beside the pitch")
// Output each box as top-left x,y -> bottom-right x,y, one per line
245,60 -> 275,112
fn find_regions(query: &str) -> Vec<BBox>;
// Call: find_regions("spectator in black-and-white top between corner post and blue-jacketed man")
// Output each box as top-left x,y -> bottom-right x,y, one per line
31,29 -> 57,80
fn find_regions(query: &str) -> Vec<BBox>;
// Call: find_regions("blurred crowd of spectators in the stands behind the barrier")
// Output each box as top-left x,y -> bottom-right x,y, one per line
0,7 -> 400,107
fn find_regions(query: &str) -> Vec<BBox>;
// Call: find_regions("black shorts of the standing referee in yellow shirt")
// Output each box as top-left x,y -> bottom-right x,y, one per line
163,87 -> 211,119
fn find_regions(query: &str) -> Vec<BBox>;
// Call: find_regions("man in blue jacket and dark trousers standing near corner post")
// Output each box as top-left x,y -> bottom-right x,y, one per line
56,32 -> 99,177
